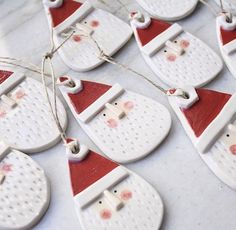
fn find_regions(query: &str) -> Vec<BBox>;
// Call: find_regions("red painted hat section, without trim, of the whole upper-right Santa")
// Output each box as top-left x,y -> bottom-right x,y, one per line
136,19 -> 171,46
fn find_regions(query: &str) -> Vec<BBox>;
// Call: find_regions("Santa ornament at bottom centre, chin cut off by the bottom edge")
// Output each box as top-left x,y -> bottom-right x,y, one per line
66,144 -> 164,230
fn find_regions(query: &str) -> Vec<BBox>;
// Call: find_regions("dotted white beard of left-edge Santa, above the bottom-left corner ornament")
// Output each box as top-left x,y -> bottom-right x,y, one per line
0,78 -> 67,153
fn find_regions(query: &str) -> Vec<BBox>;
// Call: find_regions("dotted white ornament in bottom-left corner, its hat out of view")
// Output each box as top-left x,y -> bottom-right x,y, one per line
0,142 -> 50,230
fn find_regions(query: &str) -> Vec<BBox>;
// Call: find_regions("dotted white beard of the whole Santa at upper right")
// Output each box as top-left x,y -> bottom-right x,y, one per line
135,29 -> 222,87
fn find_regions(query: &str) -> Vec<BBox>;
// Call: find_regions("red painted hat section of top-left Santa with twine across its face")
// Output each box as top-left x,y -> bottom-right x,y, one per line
49,0 -> 82,27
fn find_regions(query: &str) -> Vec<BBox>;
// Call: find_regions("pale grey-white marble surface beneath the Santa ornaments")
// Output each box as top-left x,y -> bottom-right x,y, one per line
0,0 -> 236,230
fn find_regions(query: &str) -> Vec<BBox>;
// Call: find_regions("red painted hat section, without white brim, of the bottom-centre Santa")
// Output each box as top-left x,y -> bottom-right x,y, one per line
69,151 -> 119,196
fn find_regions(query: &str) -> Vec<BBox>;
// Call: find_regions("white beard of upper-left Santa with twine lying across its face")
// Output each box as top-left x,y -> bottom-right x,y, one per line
55,6 -> 132,71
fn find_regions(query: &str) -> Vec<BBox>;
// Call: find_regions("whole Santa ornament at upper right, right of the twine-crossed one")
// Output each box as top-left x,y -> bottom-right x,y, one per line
130,12 -> 223,87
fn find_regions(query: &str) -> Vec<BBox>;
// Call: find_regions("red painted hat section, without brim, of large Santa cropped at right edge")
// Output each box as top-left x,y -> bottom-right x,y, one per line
182,89 -> 232,137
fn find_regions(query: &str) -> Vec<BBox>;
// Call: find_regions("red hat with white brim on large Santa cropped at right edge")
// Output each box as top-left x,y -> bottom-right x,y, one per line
179,89 -> 236,152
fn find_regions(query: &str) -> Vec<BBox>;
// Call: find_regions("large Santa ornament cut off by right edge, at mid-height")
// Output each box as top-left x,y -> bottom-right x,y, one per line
169,87 -> 236,189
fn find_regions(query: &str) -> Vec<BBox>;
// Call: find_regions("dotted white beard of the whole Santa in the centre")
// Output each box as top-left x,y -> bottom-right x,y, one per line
79,91 -> 171,163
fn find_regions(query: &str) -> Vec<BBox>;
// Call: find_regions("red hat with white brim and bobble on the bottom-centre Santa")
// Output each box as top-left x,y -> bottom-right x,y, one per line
67,145 -> 129,208
